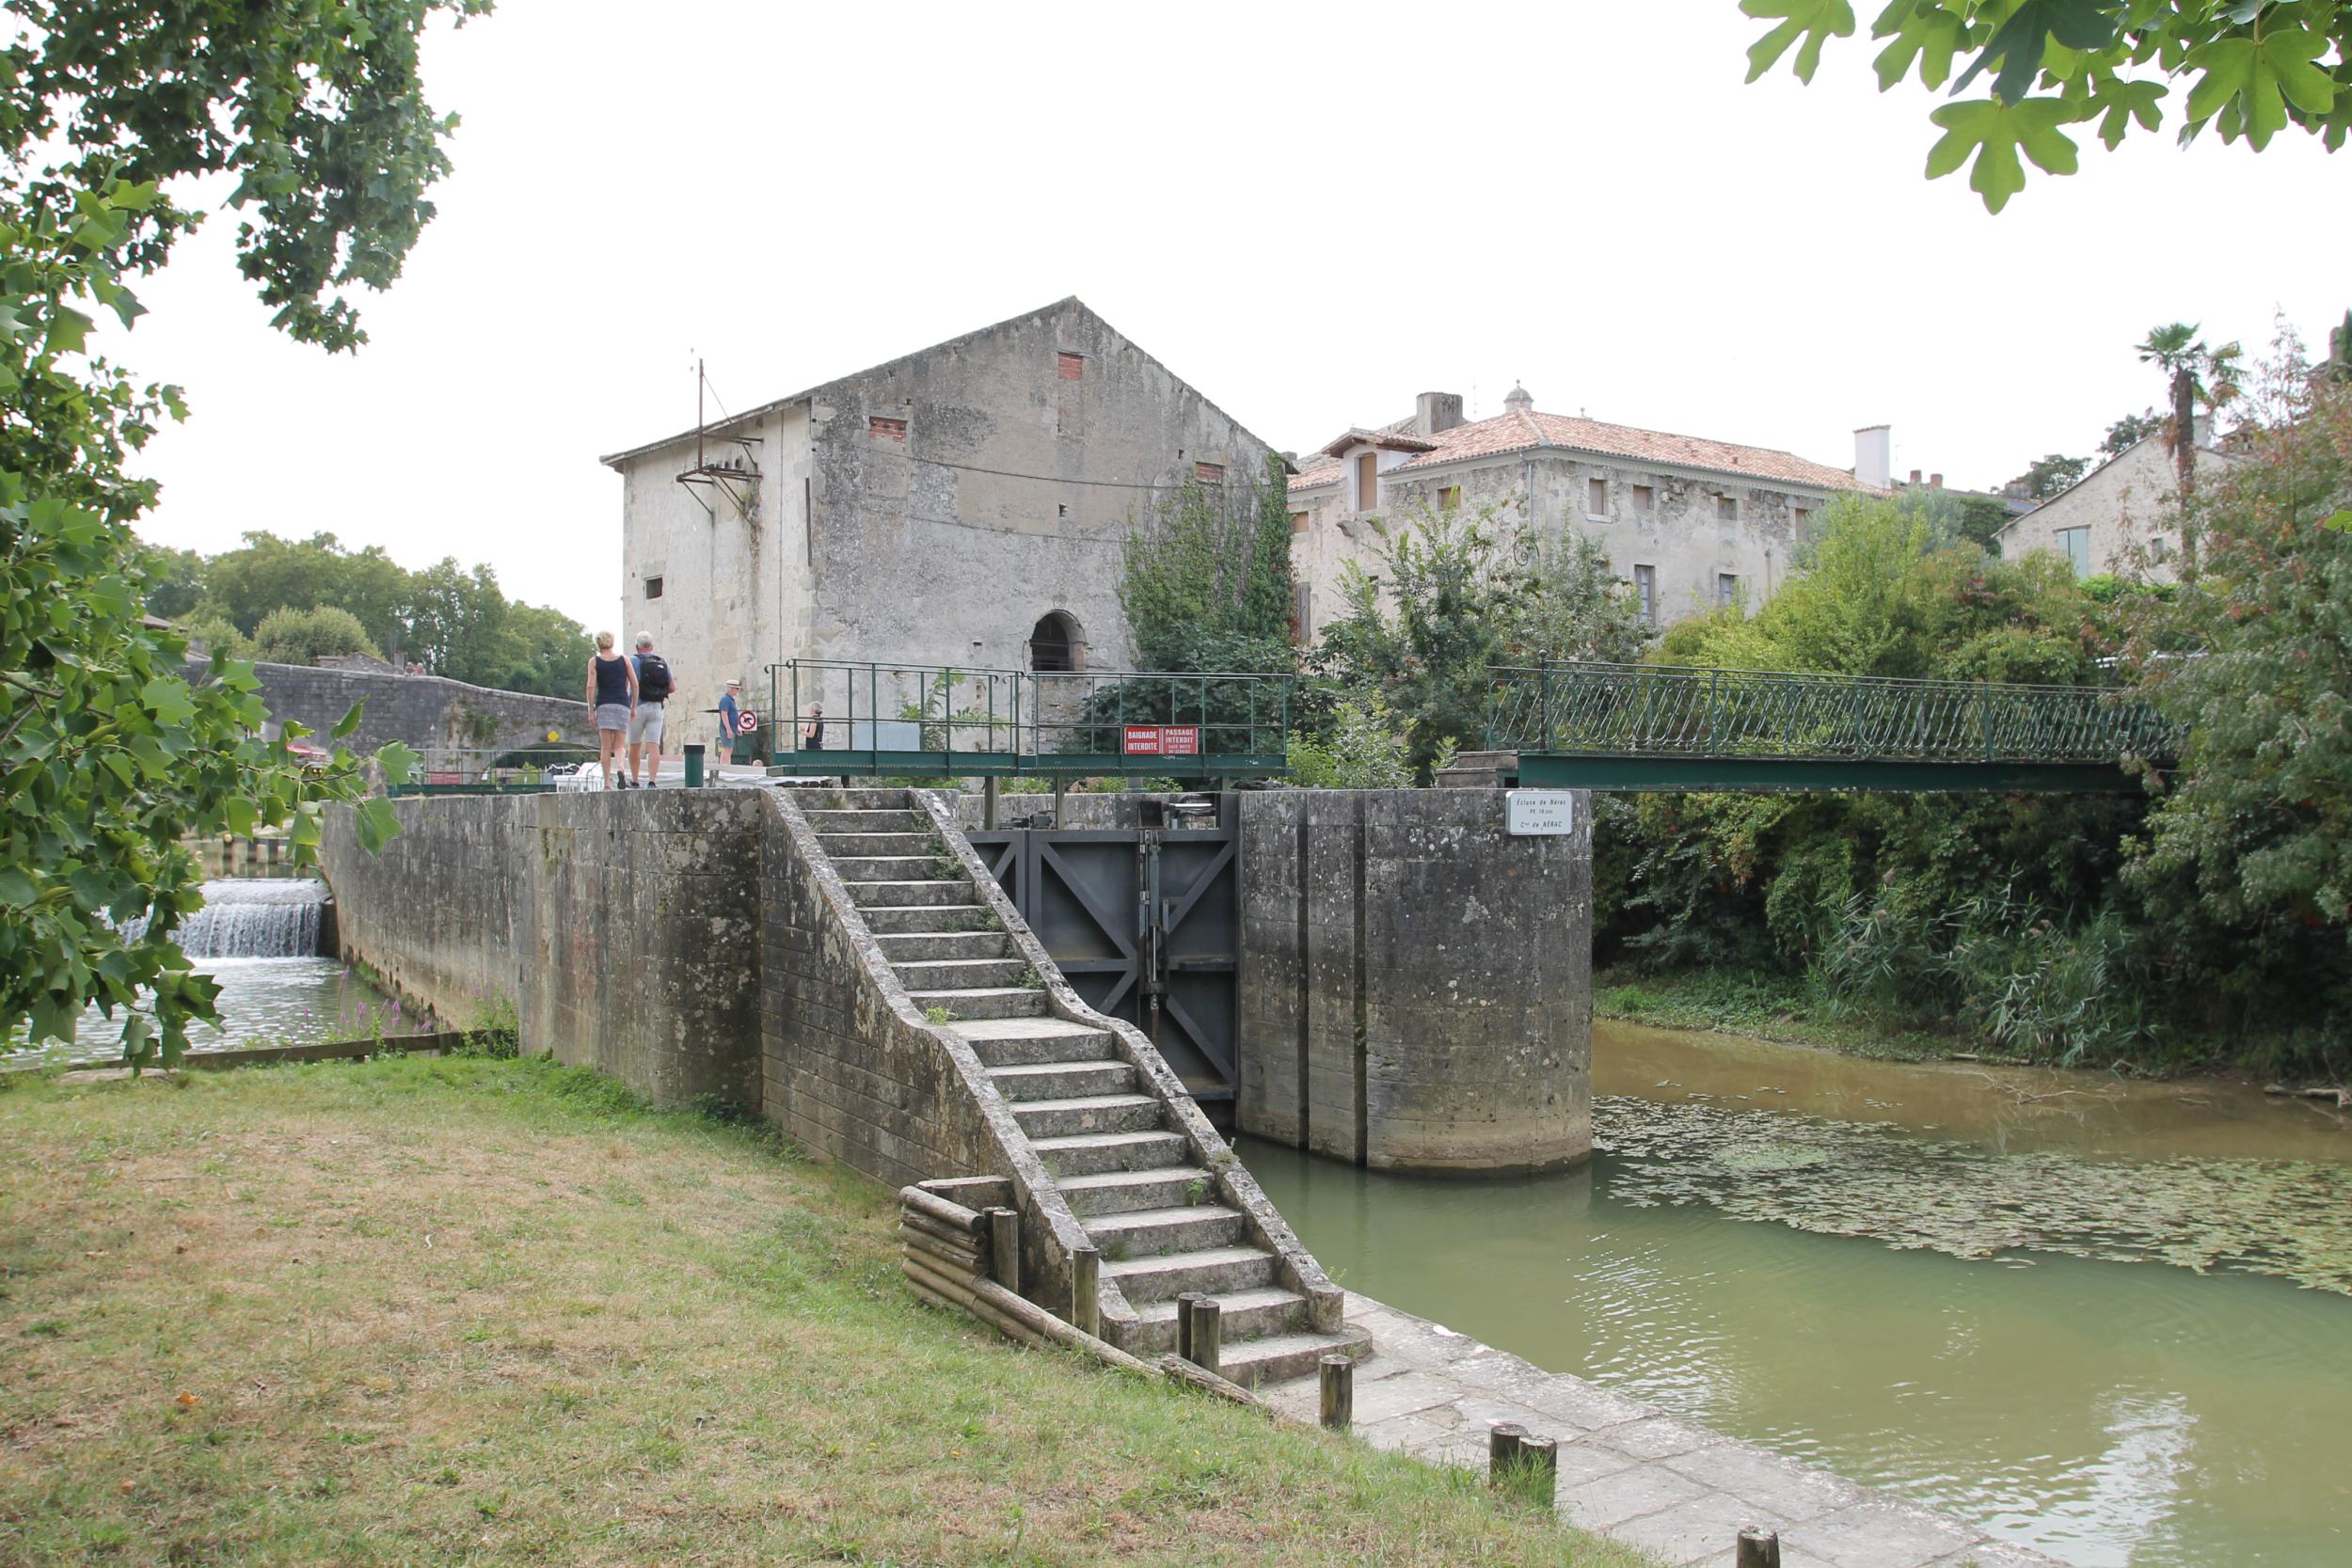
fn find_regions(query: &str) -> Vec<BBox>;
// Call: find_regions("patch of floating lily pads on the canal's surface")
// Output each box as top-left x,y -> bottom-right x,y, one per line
1593,1096 -> 2352,1295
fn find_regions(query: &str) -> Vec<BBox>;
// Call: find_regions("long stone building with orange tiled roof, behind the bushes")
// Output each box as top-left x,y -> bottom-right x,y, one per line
1292,388 -> 1889,641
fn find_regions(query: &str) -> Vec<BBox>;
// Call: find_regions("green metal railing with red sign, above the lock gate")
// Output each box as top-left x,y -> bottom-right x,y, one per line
770,658 -> 1292,778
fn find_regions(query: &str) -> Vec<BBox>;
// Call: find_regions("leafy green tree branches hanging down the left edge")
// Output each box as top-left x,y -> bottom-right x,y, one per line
0,0 -> 483,1063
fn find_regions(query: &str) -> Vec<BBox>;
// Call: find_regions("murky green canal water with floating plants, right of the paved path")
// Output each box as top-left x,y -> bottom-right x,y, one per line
1242,1025 -> 2352,1568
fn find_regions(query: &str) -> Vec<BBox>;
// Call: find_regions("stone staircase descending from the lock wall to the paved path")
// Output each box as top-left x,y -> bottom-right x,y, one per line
793,790 -> 1372,1387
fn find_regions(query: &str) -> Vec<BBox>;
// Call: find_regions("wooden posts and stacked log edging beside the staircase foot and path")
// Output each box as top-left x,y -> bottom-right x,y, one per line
898,1176 -> 1781,1568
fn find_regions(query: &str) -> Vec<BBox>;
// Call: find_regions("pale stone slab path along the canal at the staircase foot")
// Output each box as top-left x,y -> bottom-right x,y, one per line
1259,1291 -> 2063,1568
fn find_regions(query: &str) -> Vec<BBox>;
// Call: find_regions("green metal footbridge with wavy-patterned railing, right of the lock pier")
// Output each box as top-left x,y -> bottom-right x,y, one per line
1477,663 -> 2181,792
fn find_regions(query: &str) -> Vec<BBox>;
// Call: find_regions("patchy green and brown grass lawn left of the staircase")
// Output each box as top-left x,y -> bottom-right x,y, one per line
0,1058 -> 1645,1568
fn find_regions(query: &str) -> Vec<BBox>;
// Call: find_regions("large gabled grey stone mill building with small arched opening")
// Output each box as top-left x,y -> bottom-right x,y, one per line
602,298 -> 1270,734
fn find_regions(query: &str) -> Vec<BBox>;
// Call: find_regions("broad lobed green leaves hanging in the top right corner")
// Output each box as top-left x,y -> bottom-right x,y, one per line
1740,0 -> 2352,212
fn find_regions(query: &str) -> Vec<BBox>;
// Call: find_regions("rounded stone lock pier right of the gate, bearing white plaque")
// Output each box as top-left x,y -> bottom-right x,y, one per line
1237,790 -> 1593,1171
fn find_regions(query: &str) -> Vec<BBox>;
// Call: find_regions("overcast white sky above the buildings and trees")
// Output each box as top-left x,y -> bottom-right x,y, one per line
111,0 -> 2352,630
